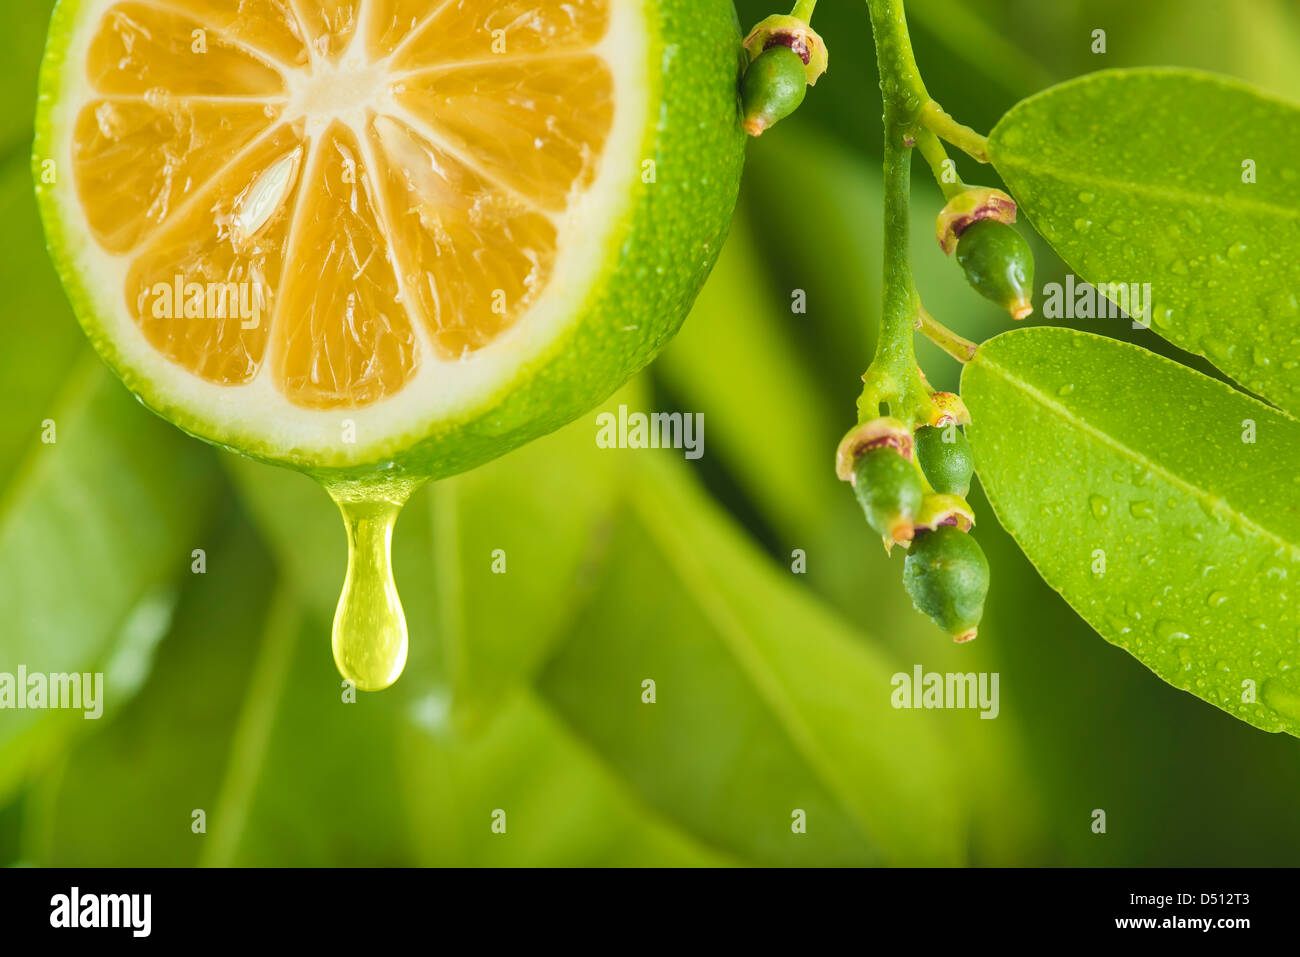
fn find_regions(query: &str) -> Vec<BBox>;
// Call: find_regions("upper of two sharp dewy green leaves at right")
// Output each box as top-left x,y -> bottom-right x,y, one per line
989,69 -> 1300,412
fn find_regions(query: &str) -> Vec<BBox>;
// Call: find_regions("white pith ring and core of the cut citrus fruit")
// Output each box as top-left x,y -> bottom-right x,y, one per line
49,0 -> 651,465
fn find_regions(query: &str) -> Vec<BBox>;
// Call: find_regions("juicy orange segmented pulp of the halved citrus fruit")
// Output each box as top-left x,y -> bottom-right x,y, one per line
73,0 -> 614,410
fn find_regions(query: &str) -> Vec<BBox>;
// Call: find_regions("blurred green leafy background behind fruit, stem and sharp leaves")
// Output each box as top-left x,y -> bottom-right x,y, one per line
0,0 -> 1300,866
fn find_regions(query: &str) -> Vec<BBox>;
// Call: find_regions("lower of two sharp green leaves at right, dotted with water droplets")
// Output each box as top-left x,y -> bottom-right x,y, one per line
962,328 -> 1300,735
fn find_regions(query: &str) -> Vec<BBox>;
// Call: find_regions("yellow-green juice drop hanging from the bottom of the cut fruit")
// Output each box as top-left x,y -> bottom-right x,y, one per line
326,482 -> 420,692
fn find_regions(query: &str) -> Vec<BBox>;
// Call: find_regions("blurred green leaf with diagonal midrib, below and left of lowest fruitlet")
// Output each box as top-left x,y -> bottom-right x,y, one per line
540,455 -> 965,865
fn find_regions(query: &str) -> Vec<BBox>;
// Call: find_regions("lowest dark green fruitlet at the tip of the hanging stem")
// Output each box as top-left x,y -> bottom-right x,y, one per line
902,525 -> 988,641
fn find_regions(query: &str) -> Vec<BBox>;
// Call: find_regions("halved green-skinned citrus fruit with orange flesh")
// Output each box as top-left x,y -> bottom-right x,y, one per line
35,0 -> 745,477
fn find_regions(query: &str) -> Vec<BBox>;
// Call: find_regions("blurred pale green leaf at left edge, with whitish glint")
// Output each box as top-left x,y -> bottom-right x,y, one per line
0,147 -> 220,794
